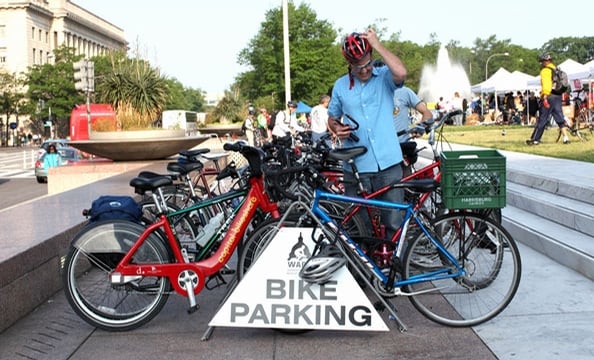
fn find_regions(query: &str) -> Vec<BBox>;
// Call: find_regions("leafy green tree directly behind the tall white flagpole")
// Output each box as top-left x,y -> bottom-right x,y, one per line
236,2 -> 345,108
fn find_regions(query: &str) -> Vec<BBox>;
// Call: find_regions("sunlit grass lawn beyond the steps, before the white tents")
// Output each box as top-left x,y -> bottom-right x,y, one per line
443,125 -> 594,162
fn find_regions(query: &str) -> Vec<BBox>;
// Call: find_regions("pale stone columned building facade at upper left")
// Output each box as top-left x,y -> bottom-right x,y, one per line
0,0 -> 128,73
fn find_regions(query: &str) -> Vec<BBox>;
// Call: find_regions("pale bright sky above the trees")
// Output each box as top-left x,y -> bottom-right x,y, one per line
71,0 -> 594,92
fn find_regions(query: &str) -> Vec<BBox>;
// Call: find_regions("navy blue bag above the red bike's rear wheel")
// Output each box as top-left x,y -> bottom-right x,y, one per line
86,195 -> 142,223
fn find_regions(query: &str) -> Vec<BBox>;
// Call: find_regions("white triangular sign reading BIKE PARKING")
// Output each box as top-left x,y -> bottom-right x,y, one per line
209,228 -> 389,331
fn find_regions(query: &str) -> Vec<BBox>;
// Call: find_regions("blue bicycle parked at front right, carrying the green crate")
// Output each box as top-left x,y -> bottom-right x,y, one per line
238,168 -> 521,331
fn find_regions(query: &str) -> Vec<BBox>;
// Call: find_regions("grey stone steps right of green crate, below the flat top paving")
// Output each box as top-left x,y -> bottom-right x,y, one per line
503,172 -> 594,280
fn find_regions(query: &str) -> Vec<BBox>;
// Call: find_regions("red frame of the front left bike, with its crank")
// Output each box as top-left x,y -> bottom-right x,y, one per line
110,177 -> 280,308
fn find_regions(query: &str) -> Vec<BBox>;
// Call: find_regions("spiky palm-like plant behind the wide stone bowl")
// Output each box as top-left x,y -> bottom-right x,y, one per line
99,58 -> 169,130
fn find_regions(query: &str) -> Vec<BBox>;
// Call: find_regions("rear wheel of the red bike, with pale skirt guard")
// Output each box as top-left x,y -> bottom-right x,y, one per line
62,220 -> 170,331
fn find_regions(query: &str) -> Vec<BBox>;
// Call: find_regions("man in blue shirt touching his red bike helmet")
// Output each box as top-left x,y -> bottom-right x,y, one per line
328,29 -> 406,237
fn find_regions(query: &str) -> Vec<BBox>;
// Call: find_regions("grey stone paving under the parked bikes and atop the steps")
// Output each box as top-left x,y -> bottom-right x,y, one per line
0,147 -> 594,360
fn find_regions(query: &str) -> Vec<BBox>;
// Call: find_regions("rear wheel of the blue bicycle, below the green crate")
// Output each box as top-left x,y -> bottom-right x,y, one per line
403,212 -> 521,327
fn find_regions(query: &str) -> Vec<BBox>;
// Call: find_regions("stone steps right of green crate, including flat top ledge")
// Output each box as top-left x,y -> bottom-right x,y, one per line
417,141 -> 594,280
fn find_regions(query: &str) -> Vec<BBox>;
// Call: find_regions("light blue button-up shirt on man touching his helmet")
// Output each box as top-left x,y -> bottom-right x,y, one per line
328,66 -> 402,173
